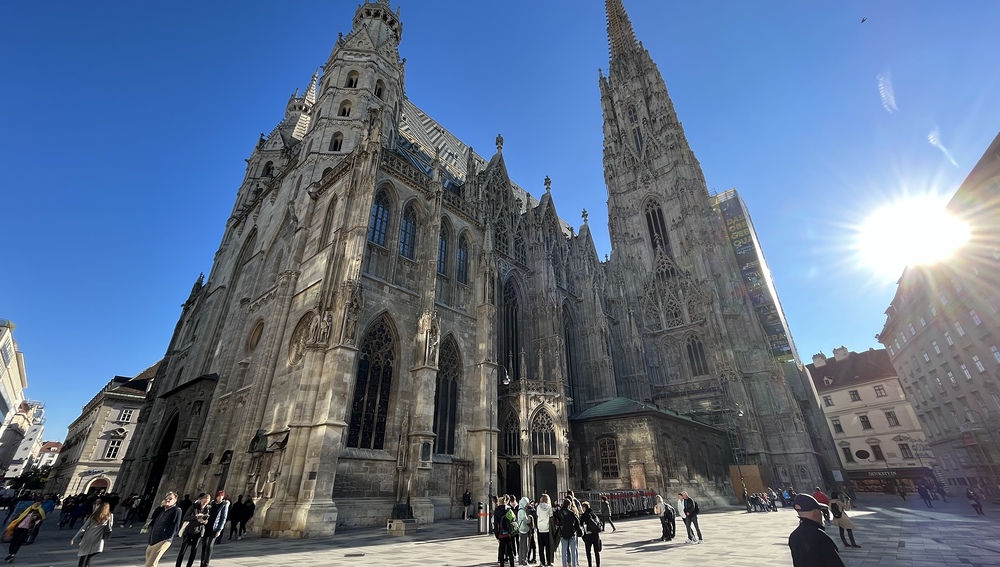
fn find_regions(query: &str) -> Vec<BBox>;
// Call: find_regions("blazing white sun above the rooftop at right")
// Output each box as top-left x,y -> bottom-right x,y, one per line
854,196 -> 969,280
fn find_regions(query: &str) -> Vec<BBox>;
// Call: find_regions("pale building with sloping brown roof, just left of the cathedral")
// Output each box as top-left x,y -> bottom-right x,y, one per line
45,362 -> 160,495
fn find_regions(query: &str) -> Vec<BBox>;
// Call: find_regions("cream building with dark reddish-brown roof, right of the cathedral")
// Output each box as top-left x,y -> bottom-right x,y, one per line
807,347 -> 939,492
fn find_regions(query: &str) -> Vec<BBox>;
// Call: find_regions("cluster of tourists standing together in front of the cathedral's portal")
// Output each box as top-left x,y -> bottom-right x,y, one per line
492,490 -> 616,567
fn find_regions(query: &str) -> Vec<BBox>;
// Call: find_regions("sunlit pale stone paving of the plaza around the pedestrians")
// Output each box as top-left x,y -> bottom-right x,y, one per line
4,495 -> 1000,567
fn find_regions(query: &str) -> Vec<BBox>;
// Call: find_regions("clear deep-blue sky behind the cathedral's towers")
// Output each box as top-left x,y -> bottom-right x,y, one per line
0,0 -> 1000,440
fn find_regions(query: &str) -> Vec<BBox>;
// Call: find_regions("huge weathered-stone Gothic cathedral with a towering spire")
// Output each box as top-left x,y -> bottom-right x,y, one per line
115,0 -> 821,537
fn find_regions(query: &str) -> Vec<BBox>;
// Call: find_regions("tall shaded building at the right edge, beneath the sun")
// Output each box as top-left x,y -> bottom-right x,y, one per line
878,131 -> 1000,500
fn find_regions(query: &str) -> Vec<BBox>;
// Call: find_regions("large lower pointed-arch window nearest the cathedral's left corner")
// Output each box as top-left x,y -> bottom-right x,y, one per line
347,317 -> 396,449
